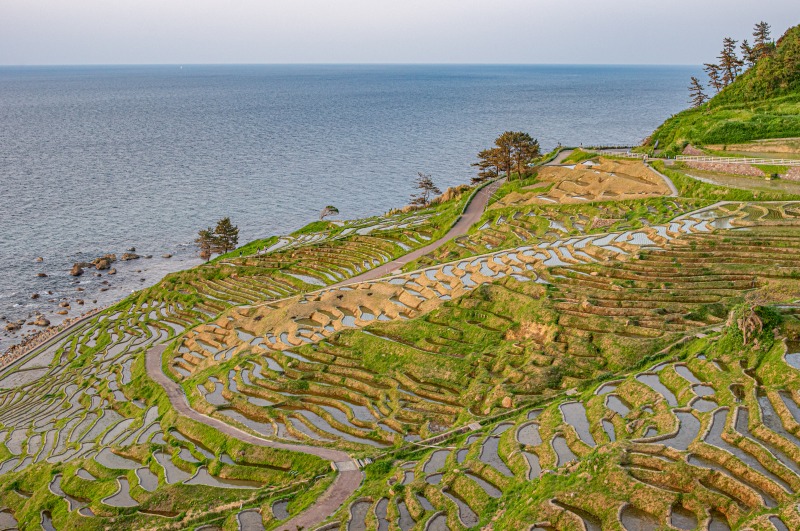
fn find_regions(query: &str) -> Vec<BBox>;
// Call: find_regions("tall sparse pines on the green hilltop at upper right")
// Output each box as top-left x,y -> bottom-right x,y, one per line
689,21 -> 775,101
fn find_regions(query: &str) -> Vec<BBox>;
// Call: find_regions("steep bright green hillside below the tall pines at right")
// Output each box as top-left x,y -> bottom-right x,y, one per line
646,26 -> 800,153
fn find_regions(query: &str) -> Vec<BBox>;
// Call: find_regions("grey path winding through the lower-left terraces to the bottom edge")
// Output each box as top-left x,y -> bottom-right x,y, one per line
145,345 -> 363,531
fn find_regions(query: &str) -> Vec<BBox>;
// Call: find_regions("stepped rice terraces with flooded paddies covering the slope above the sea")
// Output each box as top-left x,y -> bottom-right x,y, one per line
0,163 -> 800,530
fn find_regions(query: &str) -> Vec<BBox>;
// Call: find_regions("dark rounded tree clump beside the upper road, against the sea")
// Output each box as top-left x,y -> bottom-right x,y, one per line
472,131 -> 541,183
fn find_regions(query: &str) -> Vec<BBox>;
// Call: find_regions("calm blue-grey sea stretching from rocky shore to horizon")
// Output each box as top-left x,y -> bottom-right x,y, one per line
0,66 -> 697,349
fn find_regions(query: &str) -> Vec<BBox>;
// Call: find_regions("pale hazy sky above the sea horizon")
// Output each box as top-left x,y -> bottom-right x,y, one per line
0,0 -> 800,65
